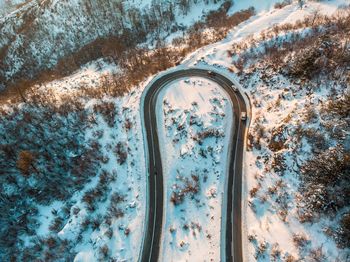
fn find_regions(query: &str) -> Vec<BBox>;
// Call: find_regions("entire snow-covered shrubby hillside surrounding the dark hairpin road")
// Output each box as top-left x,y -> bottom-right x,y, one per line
0,0 -> 350,262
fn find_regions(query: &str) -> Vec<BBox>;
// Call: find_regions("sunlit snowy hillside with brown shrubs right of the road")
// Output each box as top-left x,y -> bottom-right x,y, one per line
182,1 -> 350,261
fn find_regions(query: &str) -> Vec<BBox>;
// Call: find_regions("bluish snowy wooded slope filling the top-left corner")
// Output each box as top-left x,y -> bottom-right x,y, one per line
0,0 -> 223,89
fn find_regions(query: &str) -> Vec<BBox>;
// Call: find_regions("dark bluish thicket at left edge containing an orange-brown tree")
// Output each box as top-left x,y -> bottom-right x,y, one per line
0,103 -> 99,261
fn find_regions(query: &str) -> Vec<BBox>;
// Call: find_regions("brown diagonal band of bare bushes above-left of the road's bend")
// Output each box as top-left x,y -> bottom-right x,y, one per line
0,1 -> 254,100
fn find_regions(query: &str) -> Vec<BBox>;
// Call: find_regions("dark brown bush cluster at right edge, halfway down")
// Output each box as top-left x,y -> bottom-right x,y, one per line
301,91 -> 350,223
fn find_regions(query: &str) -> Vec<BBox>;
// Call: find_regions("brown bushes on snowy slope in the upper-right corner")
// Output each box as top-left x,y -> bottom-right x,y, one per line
230,8 -> 350,81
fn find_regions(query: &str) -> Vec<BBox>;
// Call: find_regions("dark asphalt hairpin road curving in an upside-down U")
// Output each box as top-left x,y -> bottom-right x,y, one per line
140,69 -> 247,262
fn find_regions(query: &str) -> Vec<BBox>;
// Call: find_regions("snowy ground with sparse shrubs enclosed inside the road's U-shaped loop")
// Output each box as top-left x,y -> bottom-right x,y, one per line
157,77 -> 232,261
